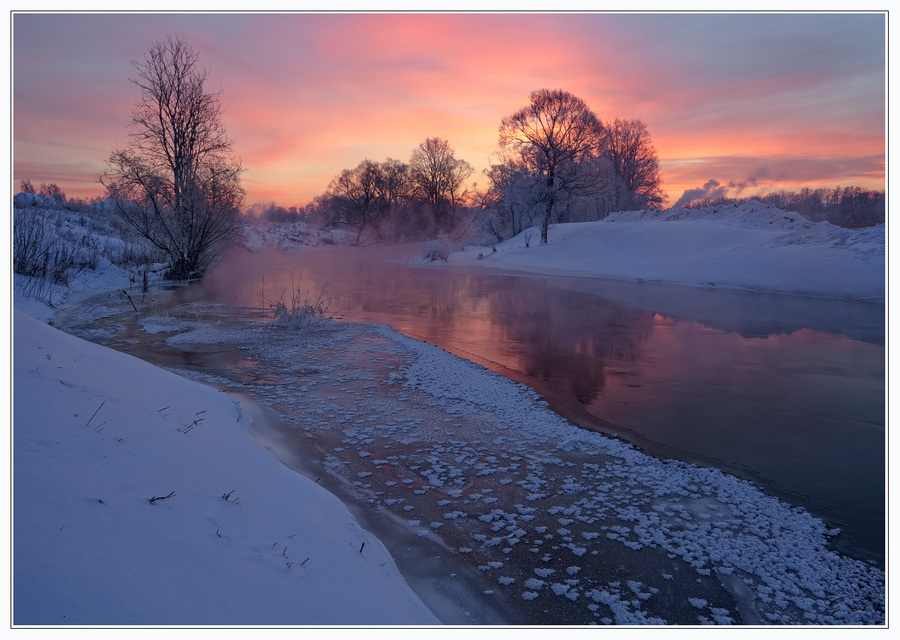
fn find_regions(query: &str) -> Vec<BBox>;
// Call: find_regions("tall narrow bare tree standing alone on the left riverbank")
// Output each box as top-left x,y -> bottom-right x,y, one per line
100,37 -> 244,279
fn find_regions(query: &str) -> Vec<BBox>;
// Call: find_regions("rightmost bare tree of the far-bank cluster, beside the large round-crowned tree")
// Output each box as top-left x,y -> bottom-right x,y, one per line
604,118 -> 666,209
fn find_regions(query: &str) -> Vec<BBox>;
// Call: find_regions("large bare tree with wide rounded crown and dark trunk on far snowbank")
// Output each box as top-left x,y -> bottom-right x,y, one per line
500,89 -> 603,244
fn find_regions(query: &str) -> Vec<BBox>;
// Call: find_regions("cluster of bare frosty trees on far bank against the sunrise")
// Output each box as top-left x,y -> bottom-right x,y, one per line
304,89 -> 665,248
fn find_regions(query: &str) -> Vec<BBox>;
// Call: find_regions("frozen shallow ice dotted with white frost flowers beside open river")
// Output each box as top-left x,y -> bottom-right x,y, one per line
58,294 -> 885,625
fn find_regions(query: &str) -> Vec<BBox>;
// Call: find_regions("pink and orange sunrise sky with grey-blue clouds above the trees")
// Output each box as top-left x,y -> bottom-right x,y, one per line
11,12 -> 886,206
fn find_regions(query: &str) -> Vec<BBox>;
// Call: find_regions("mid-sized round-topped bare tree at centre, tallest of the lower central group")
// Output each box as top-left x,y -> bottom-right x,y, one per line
409,138 -> 474,232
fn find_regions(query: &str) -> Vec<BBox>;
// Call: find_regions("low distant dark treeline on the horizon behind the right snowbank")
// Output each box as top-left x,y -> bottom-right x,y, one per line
683,187 -> 885,227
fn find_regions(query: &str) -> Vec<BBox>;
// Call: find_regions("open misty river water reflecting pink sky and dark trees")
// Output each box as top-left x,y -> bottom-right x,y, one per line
190,247 -> 885,562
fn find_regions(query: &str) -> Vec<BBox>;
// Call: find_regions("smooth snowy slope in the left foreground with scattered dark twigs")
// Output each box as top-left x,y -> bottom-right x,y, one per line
12,304 -> 437,626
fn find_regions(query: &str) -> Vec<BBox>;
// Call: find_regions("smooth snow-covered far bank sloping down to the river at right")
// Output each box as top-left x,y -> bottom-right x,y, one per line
449,202 -> 885,301
